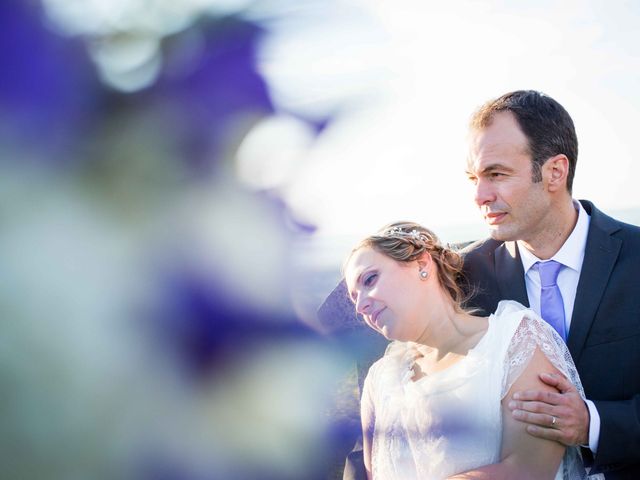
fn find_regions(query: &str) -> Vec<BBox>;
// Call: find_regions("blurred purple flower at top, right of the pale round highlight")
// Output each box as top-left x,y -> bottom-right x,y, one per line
154,17 -> 274,172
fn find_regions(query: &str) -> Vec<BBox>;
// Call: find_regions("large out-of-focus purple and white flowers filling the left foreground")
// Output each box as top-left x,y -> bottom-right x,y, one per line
0,0 -> 357,479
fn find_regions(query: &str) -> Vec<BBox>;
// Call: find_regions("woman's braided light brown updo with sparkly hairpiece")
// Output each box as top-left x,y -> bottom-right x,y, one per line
347,222 -> 466,311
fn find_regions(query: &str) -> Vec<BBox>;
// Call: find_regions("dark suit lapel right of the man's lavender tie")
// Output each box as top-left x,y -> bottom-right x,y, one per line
567,202 -> 622,363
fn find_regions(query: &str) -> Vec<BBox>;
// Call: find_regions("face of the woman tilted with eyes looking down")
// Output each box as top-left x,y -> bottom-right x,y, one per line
345,247 -> 428,341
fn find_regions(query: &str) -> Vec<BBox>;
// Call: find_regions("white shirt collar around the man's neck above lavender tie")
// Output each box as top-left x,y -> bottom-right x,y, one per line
516,200 -> 591,275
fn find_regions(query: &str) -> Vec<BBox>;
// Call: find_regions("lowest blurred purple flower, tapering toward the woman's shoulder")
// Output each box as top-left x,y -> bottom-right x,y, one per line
151,260 -> 312,381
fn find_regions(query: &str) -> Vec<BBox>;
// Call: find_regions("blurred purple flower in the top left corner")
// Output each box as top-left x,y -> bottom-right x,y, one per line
0,0 -> 102,161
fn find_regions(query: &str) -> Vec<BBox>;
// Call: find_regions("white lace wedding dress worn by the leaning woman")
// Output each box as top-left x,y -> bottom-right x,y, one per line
362,301 -> 586,480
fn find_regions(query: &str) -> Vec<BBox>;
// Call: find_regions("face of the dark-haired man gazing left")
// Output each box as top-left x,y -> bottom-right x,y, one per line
467,112 -> 551,243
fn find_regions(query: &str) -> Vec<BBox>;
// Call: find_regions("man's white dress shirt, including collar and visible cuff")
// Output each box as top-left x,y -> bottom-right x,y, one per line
517,200 -> 600,454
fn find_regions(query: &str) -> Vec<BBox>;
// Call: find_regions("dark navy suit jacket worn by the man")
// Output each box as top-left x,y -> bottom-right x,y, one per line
463,200 -> 640,479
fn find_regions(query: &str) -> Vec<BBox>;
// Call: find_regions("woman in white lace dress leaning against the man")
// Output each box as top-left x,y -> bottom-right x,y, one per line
344,223 -> 586,480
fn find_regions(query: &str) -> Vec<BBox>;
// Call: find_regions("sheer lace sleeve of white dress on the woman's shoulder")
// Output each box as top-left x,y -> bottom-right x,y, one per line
496,302 -> 587,480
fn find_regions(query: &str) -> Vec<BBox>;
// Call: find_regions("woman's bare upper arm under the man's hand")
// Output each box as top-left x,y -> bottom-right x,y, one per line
450,348 -> 565,480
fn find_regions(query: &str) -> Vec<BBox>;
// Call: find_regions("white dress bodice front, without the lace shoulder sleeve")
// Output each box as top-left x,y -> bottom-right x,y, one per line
363,342 -> 501,480
